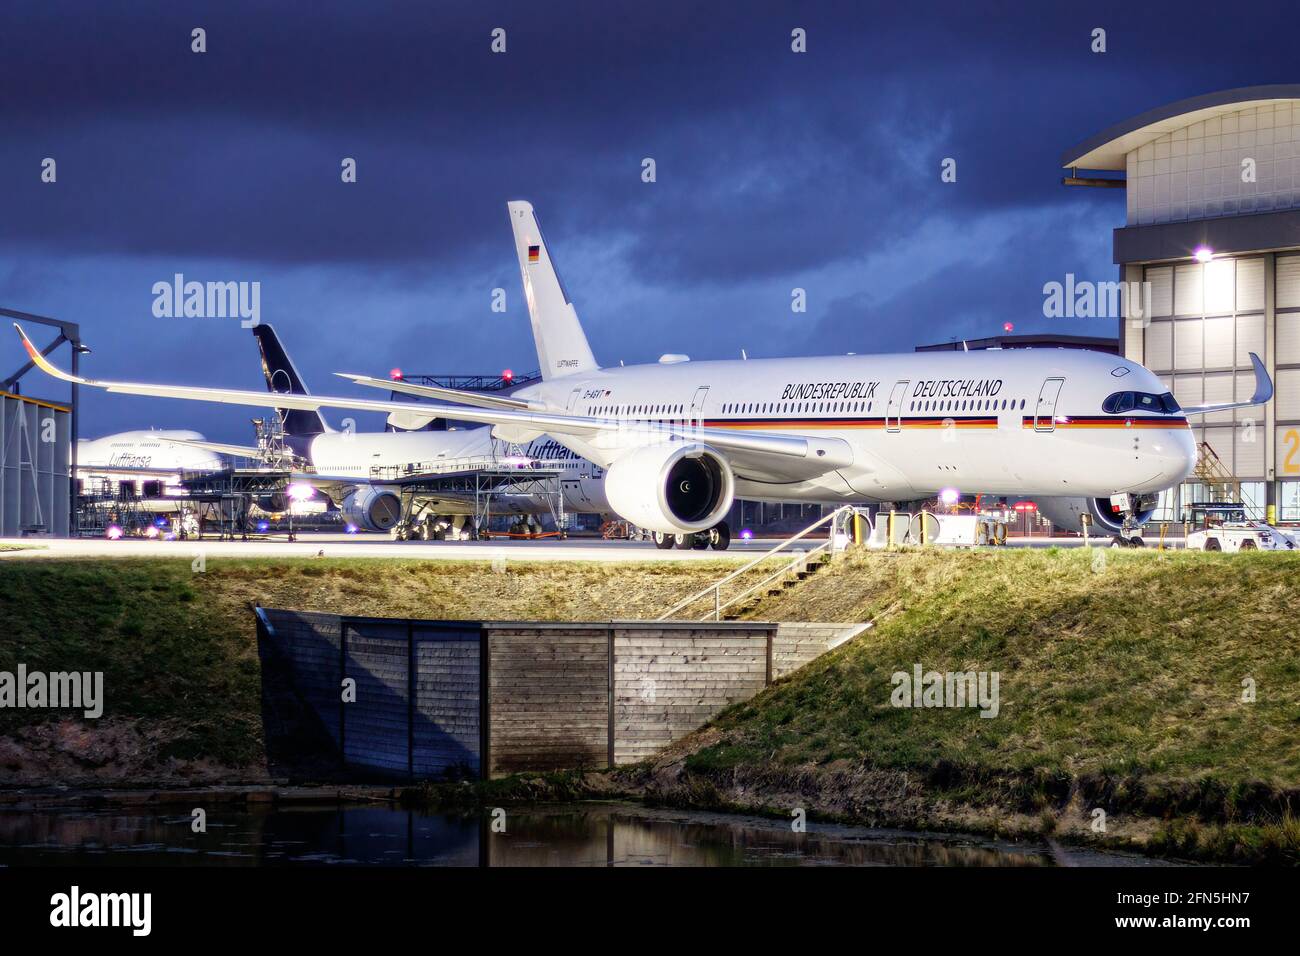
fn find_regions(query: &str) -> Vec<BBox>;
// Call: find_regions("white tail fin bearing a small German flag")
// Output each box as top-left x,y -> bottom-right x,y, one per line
506,202 -> 599,378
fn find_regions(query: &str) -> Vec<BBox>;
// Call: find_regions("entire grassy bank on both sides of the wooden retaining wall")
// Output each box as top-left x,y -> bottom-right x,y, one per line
0,550 -> 1300,863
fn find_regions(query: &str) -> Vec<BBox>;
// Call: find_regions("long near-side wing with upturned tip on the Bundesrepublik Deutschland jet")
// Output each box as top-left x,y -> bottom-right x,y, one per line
14,323 -> 854,481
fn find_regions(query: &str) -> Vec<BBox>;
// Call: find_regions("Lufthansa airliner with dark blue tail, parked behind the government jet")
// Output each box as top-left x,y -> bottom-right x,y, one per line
171,324 -> 608,538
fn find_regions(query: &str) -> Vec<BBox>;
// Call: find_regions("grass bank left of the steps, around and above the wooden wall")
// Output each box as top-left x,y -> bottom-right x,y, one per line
0,558 -> 759,784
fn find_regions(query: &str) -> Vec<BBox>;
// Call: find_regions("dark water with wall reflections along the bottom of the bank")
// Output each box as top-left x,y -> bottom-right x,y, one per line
0,804 -> 1117,866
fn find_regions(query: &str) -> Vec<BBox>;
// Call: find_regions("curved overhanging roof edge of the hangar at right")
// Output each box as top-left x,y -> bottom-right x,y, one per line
1061,83 -> 1300,170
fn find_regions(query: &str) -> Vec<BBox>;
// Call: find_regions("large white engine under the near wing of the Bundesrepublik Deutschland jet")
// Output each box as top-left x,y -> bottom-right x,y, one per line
605,445 -> 736,535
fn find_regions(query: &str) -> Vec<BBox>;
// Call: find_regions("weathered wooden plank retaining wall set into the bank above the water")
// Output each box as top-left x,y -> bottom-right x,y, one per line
259,609 -> 865,778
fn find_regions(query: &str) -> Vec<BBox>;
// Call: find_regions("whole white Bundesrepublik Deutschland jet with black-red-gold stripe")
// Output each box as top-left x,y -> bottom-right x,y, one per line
10,202 -> 1273,546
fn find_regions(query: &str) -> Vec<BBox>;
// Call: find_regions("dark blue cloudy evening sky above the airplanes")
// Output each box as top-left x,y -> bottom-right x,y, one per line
0,0 -> 1297,441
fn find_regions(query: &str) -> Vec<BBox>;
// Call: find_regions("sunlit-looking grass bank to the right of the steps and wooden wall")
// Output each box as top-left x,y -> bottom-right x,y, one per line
651,549 -> 1300,861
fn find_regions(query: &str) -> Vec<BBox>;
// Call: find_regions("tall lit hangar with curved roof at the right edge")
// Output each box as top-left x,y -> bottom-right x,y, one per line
1061,83 -> 1300,522
